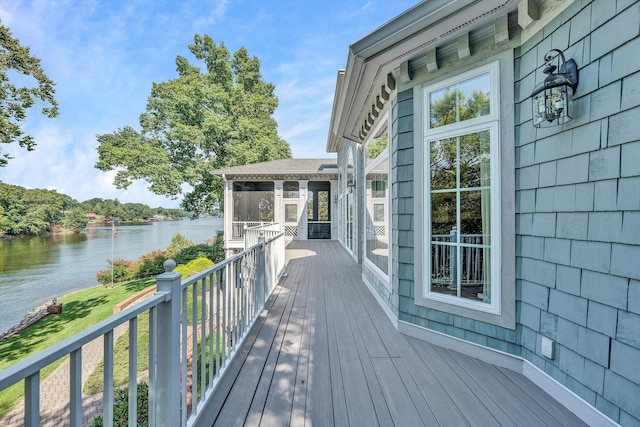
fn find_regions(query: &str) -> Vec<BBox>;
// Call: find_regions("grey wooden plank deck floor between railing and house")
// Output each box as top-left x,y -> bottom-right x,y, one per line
205,241 -> 584,427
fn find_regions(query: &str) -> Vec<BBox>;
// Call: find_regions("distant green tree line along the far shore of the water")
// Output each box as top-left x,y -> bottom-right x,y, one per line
0,182 -> 185,236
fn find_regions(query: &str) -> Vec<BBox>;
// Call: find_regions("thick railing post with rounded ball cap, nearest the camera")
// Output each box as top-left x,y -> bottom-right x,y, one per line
156,260 -> 186,426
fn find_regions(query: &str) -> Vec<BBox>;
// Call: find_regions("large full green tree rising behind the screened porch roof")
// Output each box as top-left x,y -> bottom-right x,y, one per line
96,35 -> 291,215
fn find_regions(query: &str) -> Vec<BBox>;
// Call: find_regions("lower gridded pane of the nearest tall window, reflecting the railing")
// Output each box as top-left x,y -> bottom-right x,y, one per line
429,130 -> 491,303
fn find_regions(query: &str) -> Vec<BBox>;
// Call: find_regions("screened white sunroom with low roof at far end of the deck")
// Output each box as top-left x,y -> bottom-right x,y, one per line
214,159 -> 338,254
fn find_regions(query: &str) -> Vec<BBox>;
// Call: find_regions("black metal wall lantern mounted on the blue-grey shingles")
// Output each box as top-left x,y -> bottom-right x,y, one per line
531,49 -> 578,128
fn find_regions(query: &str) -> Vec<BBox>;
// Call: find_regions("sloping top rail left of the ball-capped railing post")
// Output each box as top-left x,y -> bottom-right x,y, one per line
0,292 -> 166,390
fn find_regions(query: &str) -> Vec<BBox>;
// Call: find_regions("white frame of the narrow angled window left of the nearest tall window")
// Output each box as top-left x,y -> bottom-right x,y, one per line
362,112 -> 393,290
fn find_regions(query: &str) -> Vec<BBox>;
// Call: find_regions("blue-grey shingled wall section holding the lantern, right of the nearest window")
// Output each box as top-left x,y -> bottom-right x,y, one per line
515,0 -> 640,425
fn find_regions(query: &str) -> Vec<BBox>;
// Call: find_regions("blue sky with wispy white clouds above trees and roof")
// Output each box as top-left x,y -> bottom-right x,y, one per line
0,0 -> 418,207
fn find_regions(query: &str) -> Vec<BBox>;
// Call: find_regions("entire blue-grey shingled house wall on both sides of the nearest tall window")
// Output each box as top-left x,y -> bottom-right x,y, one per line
338,0 -> 640,425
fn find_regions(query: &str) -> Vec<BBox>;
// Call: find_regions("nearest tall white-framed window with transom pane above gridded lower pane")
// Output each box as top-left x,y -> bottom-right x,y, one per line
421,62 -> 501,314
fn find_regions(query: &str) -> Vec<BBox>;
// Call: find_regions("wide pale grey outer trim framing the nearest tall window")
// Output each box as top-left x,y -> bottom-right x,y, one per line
413,53 -> 516,329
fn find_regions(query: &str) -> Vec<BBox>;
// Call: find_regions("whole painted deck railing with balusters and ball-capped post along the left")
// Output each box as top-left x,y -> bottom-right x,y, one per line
0,233 -> 285,427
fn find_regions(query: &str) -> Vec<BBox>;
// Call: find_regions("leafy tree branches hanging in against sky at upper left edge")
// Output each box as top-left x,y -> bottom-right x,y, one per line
0,24 -> 58,167
